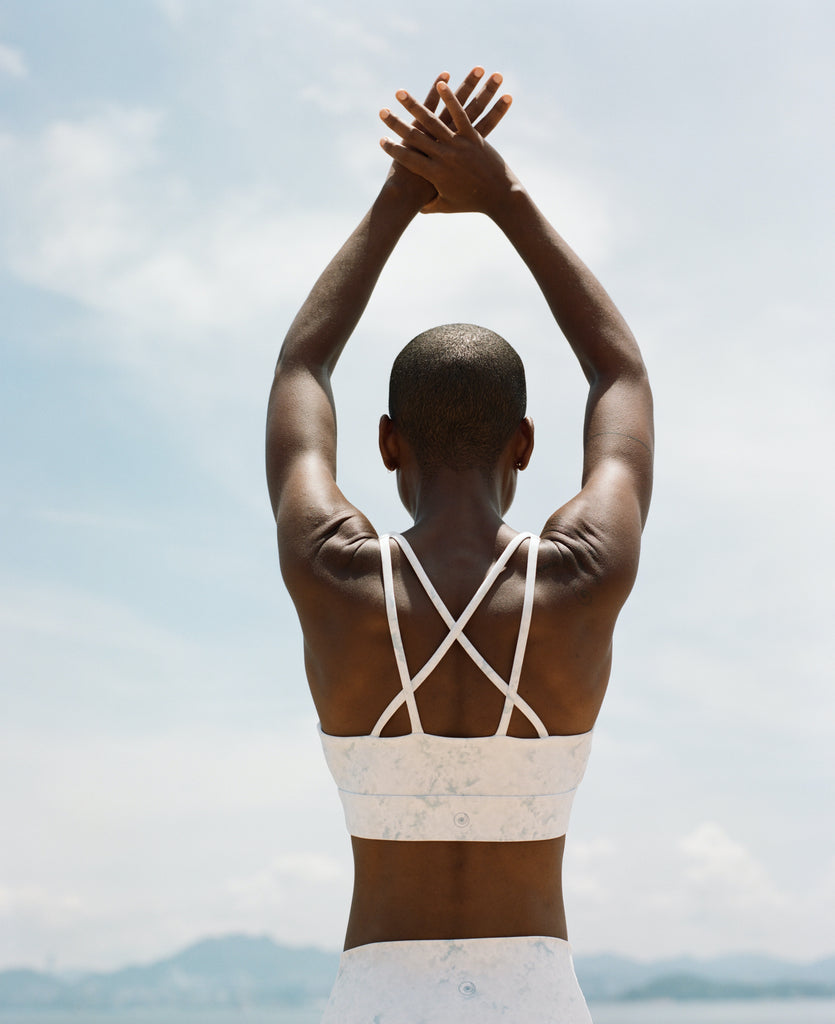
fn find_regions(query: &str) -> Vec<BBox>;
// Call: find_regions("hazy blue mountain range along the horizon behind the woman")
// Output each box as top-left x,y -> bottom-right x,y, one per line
0,935 -> 835,1010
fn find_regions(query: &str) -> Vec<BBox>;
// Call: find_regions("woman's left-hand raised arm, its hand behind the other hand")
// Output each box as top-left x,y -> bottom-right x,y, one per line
266,68 -> 516,574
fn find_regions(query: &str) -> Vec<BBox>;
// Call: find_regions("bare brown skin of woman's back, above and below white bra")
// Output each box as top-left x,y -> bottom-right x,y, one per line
299,526 -> 627,948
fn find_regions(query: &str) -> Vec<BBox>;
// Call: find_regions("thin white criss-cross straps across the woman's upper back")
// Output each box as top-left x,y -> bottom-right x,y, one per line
371,534 -> 548,737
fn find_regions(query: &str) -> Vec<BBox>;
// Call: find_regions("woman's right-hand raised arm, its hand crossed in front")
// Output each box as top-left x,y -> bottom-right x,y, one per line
381,83 -> 654,596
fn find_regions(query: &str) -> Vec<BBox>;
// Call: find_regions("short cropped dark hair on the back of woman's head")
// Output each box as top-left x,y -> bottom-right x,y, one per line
388,324 -> 528,473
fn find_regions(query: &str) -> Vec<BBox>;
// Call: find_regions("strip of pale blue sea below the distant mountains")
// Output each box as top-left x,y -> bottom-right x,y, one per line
0,999 -> 835,1024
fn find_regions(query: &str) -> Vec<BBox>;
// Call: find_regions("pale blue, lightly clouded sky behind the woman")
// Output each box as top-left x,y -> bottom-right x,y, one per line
0,0 -> 835,970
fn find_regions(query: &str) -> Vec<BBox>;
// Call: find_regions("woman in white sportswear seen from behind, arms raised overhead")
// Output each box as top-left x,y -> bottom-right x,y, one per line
267,69 -> 653,1024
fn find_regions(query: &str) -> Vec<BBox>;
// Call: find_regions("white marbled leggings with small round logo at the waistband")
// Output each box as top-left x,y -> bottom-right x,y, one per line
322,935 -> 592,1024
